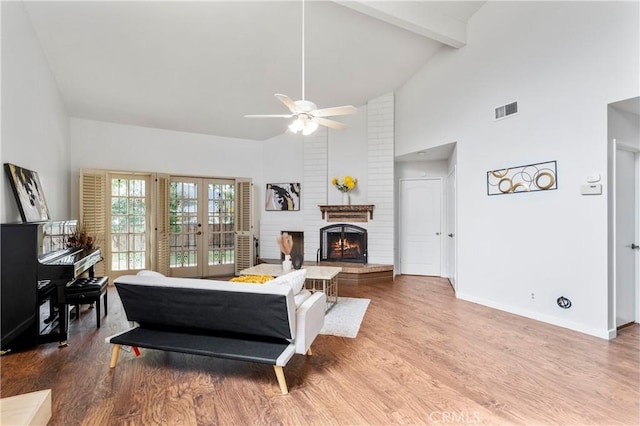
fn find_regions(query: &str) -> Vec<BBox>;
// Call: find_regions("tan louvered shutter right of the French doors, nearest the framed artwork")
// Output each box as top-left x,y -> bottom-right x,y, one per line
235,179 -> 253,275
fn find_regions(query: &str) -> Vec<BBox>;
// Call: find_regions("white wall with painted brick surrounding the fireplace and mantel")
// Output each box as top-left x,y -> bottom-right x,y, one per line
259,98 -> 394,264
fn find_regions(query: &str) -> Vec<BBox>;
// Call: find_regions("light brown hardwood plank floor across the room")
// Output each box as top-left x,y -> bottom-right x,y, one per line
0,276 -> 640,425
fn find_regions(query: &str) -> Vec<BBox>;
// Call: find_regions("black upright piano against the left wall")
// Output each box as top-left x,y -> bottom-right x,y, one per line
0,221 -> 102,353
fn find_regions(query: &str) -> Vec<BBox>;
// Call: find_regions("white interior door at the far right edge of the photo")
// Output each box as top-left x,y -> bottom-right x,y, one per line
615,149 -> 640,327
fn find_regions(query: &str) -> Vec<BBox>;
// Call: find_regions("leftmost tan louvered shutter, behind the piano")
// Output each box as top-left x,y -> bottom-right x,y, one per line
79,170 -> 109,276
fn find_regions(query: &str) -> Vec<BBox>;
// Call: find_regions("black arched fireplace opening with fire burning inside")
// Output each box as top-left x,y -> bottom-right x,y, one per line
320,224 -> 367,263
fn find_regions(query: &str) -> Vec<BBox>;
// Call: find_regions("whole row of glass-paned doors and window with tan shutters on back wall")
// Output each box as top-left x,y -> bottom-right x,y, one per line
79,169 -> 253,279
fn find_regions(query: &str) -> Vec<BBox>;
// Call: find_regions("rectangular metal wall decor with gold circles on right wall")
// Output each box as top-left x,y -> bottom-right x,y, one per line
487,160 -> 558,195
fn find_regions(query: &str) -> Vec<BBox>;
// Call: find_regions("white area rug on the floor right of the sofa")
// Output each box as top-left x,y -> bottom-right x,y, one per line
320,297 -> 371,338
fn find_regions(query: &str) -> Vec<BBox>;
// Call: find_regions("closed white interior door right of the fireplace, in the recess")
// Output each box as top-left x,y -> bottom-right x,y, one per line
399,178 -> 442,276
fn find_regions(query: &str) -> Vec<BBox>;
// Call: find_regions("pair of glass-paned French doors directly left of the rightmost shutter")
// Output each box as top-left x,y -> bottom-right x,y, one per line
169,176 -> 236,277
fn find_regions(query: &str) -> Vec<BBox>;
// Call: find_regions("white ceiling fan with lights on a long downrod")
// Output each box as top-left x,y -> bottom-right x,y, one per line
245,0 -> 357,136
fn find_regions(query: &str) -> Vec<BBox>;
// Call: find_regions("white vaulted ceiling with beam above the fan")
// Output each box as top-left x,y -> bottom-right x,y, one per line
25,0 -> 484,140
